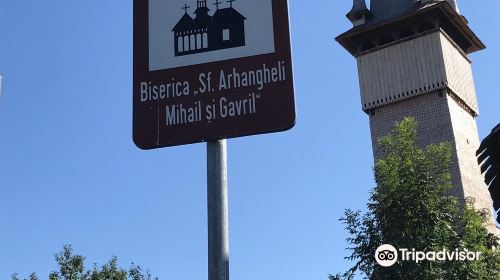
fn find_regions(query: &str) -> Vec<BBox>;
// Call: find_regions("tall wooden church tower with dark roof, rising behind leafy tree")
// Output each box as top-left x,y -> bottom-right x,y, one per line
337,0 -> 498,233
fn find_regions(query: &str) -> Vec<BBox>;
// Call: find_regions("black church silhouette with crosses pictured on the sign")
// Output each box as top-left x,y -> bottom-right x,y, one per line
172,0 -> 246,56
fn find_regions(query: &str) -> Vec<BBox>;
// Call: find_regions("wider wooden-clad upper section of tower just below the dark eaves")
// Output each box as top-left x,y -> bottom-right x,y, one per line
357,31 -> 478,114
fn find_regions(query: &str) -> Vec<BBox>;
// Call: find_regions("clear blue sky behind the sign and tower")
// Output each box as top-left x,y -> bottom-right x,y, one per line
0,0 -> 500,280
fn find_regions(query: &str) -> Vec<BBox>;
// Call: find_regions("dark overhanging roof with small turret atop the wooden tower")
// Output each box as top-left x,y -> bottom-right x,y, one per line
336,0 -> 485,56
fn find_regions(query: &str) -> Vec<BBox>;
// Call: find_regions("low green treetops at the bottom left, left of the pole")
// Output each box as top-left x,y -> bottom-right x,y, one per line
11,245 -> 158,280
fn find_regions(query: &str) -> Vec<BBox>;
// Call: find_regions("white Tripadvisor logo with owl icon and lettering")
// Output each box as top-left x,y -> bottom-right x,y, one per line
375,244 -> 481,267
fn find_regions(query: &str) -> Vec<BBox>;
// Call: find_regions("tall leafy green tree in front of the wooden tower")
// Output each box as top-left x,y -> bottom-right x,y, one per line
329,118 -> 500,280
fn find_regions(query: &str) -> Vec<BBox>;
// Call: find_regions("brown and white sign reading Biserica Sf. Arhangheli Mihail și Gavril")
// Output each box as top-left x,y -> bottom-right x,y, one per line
133,0 -> 295,149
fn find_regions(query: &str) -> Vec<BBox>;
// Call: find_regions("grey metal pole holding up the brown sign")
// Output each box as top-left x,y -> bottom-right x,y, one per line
207,139 -> 229,280
